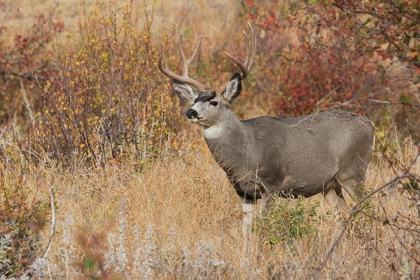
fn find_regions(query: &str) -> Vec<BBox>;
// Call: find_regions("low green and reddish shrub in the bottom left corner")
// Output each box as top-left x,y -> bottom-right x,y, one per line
0,170 -> 50,277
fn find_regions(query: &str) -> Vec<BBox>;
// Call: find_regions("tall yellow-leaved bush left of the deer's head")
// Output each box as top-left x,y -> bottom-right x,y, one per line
33,1 -> 176,164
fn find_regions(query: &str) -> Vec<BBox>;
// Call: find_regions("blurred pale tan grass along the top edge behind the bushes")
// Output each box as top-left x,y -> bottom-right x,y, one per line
0,0 -> 246,52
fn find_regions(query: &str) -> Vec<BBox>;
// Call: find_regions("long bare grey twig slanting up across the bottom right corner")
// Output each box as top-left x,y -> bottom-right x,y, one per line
313,152 -> 420,278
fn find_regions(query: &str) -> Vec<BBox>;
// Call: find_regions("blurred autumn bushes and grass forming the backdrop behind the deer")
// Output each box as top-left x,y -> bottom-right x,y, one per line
0,0 -> 420,275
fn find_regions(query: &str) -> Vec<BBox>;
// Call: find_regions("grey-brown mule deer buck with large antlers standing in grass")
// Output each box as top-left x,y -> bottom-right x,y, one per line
159,23 -> 374,240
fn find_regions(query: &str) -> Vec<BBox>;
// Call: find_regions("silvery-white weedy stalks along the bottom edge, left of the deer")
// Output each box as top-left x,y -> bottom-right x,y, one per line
52,199 -> 227,279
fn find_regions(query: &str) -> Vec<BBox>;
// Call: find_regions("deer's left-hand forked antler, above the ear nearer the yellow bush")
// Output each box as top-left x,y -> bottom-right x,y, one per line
159,31 -> 205,90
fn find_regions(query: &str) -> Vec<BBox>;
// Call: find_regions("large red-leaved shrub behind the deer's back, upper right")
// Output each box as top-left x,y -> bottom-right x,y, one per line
243,0 -> 420,140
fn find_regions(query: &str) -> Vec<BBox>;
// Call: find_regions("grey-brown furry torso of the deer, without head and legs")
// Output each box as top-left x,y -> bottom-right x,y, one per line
205,111 -> 374,200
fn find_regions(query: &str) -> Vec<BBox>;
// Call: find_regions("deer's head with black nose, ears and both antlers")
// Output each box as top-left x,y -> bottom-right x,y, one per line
159,22 -> 257,128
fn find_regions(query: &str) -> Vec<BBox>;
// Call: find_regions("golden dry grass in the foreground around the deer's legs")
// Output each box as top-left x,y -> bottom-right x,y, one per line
13,139 -> 420,279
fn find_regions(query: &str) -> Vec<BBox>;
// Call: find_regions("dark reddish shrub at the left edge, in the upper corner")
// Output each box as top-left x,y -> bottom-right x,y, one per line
0,1 -> 64,128
